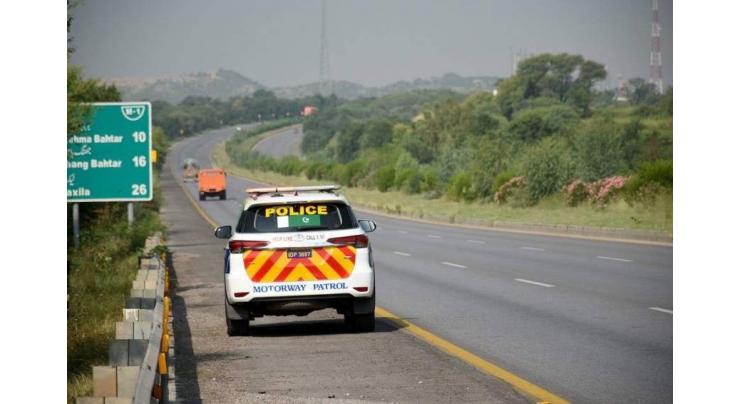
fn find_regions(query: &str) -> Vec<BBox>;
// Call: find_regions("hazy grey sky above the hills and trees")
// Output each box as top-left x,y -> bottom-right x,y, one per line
72,0 -> 673,86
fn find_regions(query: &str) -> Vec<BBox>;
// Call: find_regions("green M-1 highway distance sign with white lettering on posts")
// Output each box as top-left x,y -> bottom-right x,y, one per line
67,102 -> 153,202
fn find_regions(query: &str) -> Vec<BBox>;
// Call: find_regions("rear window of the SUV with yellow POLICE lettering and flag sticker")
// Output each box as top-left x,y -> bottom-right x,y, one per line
237,203 -> 357,233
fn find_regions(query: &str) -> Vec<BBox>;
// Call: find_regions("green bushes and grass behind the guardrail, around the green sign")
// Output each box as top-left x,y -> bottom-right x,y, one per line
67,66 -> 169,403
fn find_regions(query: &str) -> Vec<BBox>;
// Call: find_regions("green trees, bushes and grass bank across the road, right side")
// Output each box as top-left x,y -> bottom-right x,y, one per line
222,54 -> 673,233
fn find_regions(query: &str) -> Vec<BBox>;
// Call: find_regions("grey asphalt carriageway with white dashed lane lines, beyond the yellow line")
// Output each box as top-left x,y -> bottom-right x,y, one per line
170,125 -> 673,403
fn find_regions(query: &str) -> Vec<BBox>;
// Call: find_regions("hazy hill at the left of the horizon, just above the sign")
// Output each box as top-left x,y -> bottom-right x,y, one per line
106,69 -> 266,103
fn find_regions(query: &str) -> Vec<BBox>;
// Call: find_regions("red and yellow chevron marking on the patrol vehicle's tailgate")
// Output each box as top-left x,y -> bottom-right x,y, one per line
243,246 -> 355,283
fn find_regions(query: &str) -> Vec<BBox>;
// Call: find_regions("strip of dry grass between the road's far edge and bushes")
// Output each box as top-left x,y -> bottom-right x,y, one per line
211,143 -> 673,234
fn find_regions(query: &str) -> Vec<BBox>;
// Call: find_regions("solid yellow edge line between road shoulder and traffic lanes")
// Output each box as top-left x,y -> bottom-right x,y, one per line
171,155 -> 569,404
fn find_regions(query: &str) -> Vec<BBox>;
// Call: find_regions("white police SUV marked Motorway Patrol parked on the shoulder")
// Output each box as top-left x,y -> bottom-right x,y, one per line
215,185 -> 376,335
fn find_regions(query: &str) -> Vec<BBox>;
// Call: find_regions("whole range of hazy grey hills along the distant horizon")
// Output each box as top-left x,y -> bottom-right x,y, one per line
107,69 -> 499,103
